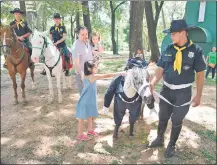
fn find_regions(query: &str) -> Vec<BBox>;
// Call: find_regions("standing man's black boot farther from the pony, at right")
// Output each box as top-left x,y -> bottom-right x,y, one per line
165,125 -> 182,158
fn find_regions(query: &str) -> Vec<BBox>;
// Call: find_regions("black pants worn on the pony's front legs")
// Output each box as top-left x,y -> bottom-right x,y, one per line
114,96 -> 142,126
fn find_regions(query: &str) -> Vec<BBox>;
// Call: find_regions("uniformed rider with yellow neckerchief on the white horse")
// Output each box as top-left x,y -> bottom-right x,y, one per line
41,13 -> 71,76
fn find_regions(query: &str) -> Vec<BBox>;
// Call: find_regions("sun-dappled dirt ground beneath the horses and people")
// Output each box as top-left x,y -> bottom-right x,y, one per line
1,63 -> 216,164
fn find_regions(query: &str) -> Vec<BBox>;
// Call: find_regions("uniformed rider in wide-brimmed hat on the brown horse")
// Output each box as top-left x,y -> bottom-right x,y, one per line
4,8 -> 34,68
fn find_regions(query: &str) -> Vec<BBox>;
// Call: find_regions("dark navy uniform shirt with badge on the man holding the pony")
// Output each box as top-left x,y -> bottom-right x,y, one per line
157,41 -> 206,85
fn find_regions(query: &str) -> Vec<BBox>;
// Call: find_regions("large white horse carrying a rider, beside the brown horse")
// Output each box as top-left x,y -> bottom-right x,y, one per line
31,30 -> 72,103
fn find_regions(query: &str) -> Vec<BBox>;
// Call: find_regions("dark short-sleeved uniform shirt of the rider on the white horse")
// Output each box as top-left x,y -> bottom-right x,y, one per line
50,25 -> 67,48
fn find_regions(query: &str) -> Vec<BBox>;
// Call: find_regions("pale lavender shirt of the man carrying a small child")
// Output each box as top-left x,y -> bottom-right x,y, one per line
71,39 -> 93,71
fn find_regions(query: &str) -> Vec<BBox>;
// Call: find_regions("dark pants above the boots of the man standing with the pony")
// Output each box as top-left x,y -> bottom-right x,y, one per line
159,86 -> 192,126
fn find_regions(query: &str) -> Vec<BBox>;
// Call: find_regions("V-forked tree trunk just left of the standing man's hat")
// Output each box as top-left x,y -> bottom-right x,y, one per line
145,1 -> 164,60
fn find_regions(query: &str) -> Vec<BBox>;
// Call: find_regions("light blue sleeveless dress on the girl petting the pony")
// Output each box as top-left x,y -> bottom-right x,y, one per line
75,78 -> 98,119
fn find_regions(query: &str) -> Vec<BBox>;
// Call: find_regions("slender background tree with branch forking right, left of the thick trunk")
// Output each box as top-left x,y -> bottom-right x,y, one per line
109,1 -> 126,54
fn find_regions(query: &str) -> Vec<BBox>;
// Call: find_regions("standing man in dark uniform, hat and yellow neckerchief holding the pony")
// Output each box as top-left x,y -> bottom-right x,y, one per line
149,20 -> 206,157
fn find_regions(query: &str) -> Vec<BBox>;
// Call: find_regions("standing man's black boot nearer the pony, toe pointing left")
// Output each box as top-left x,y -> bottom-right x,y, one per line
149,121 -> 168,148
